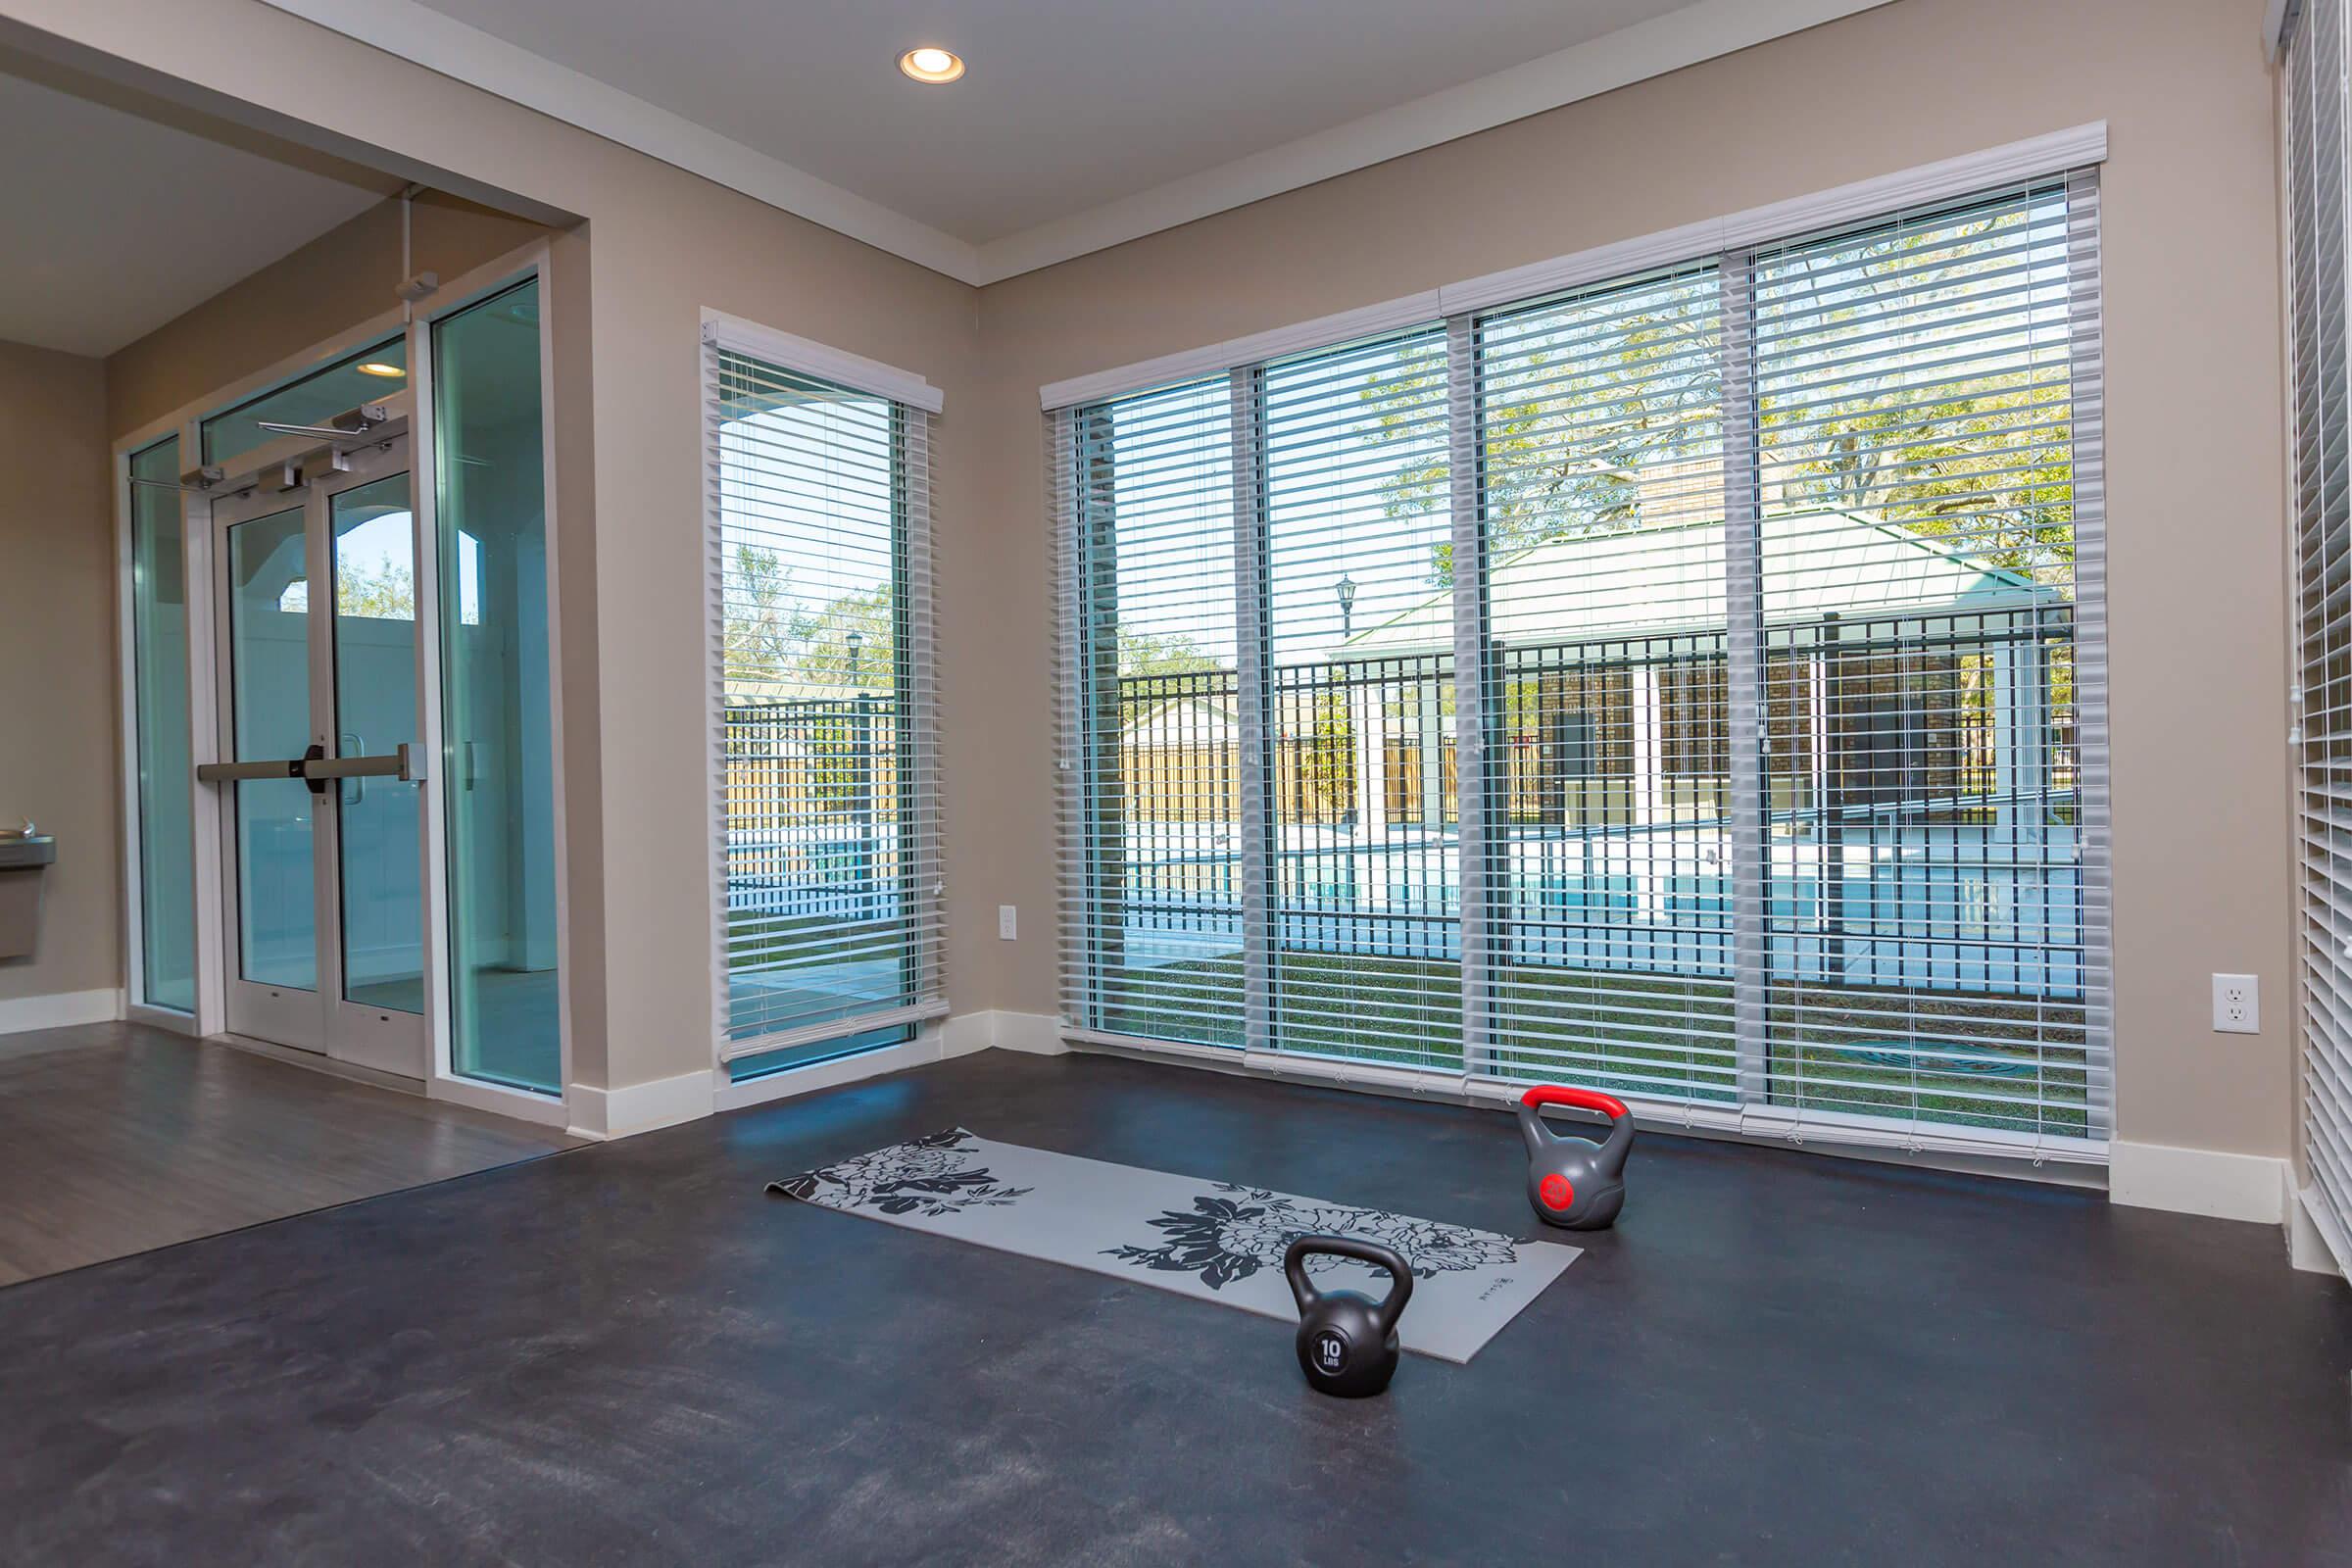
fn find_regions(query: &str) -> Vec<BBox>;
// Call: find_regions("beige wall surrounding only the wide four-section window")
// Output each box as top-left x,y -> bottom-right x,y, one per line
978,0 -> 2293,1154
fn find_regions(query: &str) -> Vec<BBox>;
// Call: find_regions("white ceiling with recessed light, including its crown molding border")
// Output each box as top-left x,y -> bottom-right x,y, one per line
269,0 -> 1888,282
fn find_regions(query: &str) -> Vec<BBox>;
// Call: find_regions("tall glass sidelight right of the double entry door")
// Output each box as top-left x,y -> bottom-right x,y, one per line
433,279 -> 563,1091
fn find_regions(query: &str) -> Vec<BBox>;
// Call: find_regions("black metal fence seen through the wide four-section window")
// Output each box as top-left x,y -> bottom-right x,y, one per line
1092,607 -> 2086,997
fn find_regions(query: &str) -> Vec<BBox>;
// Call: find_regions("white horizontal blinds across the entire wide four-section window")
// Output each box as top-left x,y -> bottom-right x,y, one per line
1052,170 -> 2112,1159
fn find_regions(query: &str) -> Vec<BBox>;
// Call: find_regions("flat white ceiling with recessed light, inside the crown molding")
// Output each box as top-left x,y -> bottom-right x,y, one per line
425,0 -> 1691,244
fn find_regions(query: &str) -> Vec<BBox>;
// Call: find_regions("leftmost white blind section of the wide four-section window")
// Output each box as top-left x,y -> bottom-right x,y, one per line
1052,376 -> 1245,1046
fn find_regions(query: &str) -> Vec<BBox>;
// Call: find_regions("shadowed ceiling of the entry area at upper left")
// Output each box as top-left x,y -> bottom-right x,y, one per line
0,59 -> 398,355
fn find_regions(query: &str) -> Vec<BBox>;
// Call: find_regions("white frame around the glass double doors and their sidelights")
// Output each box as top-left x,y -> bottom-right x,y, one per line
113,240 -> 581,1126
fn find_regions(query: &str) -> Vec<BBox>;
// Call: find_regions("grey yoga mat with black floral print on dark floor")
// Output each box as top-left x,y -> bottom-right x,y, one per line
766,1128 -> 1581,1363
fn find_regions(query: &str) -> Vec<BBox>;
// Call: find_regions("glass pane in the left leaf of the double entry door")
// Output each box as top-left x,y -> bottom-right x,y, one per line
228,506 -> 318,990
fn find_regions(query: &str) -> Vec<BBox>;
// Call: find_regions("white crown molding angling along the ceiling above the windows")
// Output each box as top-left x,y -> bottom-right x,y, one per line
264,0 -> 1893,284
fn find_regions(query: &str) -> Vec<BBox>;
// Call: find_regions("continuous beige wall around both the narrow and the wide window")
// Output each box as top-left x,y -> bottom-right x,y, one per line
10,0 -> 2291,1154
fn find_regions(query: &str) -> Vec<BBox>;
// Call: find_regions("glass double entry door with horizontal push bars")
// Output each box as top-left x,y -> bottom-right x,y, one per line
198,435 -> 428,1077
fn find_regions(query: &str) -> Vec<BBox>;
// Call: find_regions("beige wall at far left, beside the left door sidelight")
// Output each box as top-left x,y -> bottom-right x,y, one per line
0,343 -> 122,1004
